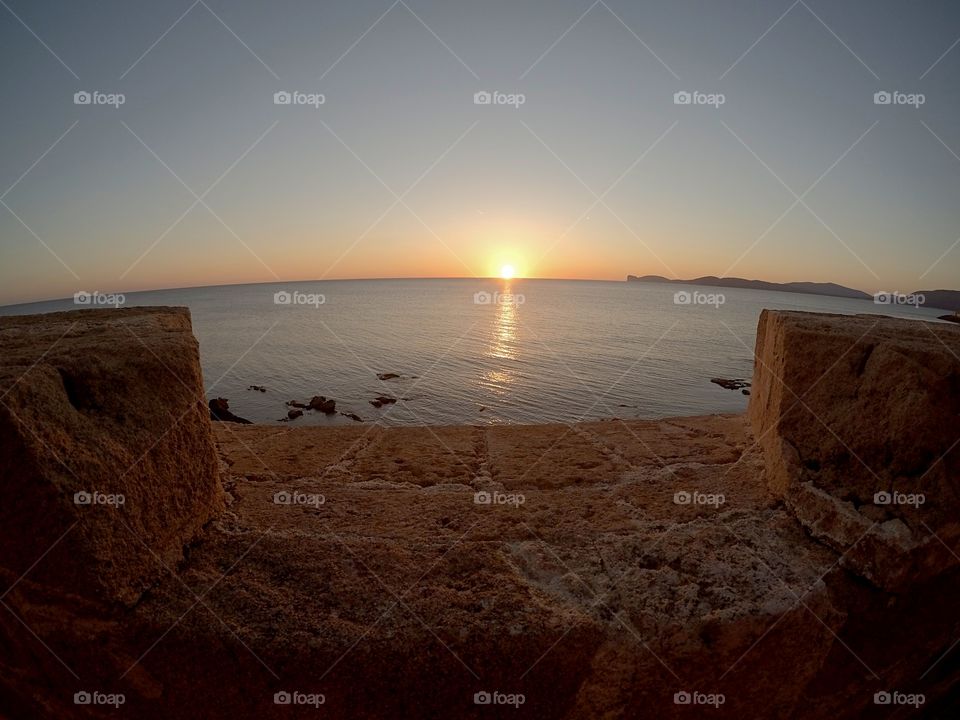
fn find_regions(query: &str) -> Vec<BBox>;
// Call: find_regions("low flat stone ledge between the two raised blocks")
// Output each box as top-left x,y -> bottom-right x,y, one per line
0,310 -> 960,720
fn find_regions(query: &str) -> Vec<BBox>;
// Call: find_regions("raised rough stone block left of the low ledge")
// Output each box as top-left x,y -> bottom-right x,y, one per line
0,308 -> 223,604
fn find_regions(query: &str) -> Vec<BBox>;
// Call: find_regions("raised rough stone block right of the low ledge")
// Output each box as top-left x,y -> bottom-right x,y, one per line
749,310 -> 960,589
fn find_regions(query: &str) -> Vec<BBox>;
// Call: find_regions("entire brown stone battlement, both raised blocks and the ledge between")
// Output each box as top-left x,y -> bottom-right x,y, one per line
0,309 -> 960,720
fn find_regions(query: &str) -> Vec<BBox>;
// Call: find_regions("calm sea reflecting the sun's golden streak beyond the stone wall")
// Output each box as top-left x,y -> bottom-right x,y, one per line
0,280 -> 943,425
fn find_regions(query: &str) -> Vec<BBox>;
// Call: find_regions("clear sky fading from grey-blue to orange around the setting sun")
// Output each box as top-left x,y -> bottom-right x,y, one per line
0,0 -> 960,304
